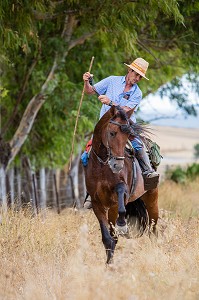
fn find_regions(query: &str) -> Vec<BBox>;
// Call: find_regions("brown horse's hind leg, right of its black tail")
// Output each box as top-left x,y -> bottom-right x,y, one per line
141,188 -> 159,235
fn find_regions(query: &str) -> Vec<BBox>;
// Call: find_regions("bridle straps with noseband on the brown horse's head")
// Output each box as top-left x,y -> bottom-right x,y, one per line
91,119 -> 134,165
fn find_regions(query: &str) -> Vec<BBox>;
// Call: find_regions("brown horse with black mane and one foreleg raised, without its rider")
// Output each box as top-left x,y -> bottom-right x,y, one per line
85,106 -> 158,263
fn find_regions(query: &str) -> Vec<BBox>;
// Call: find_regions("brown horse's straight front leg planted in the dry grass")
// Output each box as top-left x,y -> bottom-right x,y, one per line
92,202 -> 116,264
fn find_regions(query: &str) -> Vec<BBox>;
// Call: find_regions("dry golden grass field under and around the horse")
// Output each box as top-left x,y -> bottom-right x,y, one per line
0,182 -> 199,300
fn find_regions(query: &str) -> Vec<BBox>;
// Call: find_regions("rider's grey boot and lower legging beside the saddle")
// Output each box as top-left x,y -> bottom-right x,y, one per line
135,148 -> 159,178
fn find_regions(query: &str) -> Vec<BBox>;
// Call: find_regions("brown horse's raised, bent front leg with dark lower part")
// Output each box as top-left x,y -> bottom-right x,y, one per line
115,182 -> 128,234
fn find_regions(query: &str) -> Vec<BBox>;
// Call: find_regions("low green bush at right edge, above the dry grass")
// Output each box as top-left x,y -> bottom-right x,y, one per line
167,163 -> 199,184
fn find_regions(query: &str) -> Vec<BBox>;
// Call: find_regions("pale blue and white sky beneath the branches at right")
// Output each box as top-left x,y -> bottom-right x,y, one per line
137,93 -> 199,128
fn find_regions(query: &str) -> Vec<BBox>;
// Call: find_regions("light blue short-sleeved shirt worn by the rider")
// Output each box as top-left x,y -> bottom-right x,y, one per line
94,76 -> 142,122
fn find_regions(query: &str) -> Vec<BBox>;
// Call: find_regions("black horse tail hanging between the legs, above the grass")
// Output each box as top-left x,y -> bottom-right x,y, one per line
126,198 -> 149,237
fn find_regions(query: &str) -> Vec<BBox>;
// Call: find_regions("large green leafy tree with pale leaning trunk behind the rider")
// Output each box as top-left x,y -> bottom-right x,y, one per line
0,0 -> 199,171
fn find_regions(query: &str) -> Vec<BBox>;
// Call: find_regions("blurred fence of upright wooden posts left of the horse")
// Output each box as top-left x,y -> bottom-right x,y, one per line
0,168 -> 85,214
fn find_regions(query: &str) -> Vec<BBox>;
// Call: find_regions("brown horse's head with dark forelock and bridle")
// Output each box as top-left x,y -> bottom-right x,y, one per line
102,106 -> 135,173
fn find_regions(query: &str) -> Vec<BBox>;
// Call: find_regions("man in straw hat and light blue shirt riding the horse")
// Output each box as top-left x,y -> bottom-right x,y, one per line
83,58 -> 159,208
